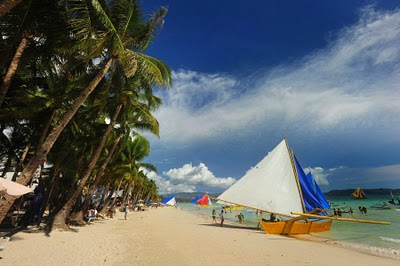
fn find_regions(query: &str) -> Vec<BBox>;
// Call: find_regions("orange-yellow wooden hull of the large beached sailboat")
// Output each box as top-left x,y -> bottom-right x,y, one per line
260,220 -> 332,235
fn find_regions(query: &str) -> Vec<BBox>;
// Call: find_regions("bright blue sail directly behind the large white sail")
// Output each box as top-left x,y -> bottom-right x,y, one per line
294,156 -> 330,212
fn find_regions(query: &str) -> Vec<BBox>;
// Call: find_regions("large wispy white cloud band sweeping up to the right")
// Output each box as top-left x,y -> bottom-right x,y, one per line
156,8 -> 400,144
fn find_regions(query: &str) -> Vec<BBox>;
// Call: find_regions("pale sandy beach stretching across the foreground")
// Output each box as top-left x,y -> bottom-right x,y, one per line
0,208 -> 400,266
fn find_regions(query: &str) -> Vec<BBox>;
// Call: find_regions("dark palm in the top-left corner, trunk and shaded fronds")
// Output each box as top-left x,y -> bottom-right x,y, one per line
0,0 -> 69,107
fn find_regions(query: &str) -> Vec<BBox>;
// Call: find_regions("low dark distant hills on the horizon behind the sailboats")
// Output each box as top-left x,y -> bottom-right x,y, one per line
162,188 -> 400,202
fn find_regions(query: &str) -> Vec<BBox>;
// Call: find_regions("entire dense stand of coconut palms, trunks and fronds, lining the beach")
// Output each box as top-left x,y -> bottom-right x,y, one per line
0,0 -> 171,228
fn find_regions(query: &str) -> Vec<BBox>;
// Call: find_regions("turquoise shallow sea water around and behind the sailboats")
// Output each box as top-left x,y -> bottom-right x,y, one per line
178,196 -> 400,259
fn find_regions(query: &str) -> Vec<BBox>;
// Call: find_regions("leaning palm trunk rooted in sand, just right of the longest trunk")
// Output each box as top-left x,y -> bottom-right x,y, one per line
73,135 -> 123,221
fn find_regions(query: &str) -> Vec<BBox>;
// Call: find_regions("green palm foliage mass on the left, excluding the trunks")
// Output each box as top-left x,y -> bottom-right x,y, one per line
0,0 -> 171,216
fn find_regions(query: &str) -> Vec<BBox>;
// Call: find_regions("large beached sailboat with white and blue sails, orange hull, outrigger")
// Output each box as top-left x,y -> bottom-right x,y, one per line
217,138 -> 388,235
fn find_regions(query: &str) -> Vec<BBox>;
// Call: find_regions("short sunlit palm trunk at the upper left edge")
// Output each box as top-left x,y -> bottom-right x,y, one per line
0,35 -> 28,108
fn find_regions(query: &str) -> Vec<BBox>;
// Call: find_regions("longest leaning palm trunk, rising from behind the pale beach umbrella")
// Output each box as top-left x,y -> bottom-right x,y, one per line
0,58 -> 113,224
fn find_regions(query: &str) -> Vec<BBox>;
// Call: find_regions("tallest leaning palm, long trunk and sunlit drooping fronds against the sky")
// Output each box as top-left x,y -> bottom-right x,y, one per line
17,0 -> 170,185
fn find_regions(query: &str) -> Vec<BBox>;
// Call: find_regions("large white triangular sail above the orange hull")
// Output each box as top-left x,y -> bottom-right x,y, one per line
218,140 -> 303,216
